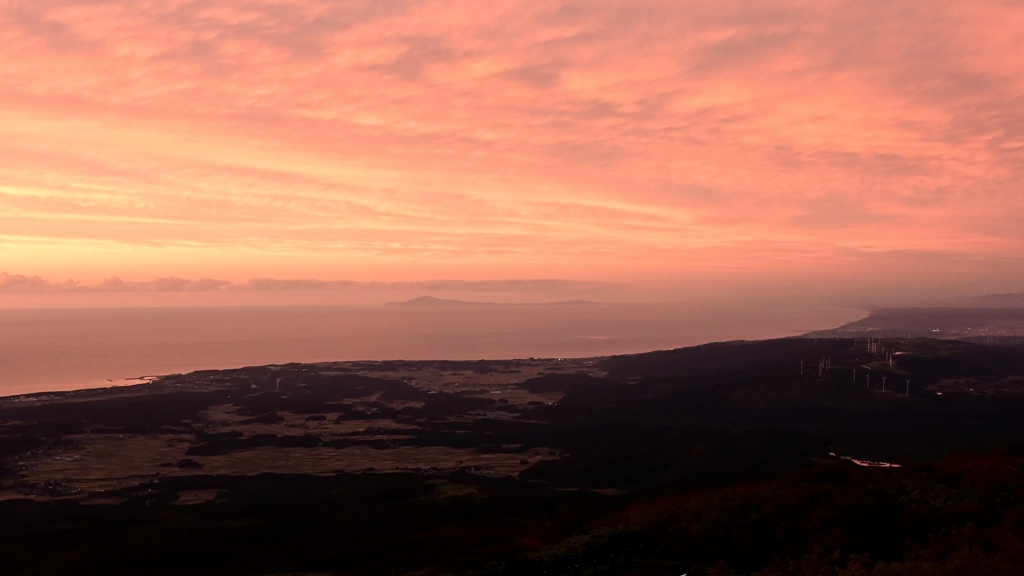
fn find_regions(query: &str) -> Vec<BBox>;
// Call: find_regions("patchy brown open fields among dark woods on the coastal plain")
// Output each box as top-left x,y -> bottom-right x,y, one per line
0,360 -> 603,502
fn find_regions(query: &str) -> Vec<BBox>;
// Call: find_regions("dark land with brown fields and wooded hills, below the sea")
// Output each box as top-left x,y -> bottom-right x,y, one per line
0,337 -> 1024,576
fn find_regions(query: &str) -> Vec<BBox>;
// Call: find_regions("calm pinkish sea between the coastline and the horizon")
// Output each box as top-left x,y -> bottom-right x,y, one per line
0,302 -> 866,396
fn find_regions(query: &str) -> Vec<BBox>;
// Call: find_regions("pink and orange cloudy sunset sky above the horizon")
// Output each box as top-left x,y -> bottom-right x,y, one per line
0,0 -> 1024,306
